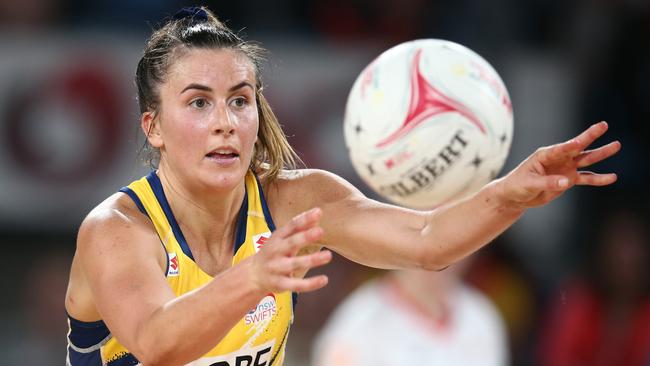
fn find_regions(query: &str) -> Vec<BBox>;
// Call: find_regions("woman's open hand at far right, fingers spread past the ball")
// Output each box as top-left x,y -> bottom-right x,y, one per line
497,122 -> 621,208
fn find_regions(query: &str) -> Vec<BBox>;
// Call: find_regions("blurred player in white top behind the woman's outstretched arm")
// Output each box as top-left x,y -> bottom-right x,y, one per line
312,261 -> 508,366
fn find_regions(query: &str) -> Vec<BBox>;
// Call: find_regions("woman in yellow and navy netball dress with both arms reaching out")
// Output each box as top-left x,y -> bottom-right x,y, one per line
66,8 -> 620,366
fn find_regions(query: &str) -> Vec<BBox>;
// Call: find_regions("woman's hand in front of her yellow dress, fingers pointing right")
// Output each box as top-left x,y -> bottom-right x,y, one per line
250,208 -> 332,293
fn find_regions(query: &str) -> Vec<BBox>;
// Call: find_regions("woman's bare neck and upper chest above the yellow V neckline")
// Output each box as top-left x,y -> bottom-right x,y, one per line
158,165 -> 245,259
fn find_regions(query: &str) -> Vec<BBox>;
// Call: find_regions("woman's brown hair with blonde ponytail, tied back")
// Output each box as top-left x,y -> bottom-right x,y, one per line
135,7 -> 304,181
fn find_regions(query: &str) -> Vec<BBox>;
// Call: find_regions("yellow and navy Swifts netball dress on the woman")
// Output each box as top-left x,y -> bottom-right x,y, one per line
66,172 -> 293,366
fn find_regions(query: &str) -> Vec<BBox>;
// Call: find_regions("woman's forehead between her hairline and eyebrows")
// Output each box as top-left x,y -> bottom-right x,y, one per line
166,48 -> 255,90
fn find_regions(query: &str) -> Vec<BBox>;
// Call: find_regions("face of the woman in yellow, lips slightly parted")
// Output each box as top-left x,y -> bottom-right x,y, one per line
157,49 -> 259,189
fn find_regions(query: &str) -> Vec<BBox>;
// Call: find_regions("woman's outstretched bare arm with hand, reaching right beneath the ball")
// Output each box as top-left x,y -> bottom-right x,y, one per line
305,123 -> 620,270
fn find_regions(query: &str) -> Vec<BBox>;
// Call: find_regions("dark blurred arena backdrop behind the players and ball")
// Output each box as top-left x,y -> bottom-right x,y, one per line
0,0 -> 650,366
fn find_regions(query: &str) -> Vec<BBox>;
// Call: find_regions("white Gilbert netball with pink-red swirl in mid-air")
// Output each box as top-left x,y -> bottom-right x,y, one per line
344,39 -> 513,208
